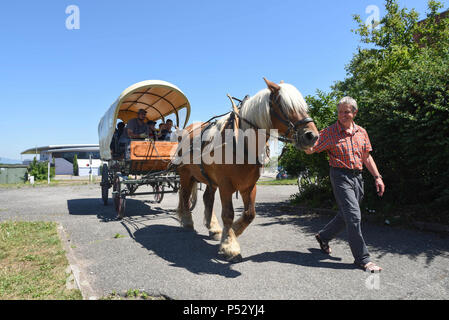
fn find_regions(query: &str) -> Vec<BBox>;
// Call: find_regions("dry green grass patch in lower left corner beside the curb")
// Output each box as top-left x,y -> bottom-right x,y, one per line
0,222 -> 82,300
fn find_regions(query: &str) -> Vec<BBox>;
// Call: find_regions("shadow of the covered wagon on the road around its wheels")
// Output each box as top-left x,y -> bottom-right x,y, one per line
67,198 -> 174,222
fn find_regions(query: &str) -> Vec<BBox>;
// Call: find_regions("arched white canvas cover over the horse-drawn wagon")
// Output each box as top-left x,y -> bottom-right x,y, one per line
98,80 -> 190,160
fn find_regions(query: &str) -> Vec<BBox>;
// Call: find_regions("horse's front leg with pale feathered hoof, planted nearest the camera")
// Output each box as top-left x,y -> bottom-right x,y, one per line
219,186 -> 242,262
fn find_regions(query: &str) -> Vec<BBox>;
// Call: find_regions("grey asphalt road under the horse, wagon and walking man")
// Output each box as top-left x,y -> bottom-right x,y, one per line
0,185 -> 449,300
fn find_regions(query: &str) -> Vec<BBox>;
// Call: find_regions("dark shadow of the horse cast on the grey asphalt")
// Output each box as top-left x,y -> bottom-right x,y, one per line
133,225 -> 241,278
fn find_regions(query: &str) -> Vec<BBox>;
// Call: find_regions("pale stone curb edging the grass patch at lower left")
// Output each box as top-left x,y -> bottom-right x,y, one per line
57,223 -> 99,300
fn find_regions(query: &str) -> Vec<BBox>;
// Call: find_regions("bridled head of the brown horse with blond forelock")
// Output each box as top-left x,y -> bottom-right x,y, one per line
264,78 -> 319,150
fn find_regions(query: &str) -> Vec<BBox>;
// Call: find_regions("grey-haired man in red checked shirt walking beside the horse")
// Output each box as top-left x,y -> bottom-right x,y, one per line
305,97 -> 385,272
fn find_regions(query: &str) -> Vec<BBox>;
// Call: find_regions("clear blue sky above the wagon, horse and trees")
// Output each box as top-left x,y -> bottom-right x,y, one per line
0,0 -> 434,159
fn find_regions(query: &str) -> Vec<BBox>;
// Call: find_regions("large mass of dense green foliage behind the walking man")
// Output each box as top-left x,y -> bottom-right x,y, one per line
286,0 -> 449,222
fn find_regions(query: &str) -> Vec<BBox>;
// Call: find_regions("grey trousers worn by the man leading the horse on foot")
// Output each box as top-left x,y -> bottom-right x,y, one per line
319,167 -> 371,264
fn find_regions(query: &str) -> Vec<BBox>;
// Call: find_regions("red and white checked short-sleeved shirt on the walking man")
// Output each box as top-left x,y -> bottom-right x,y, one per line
313,121 -> 373,170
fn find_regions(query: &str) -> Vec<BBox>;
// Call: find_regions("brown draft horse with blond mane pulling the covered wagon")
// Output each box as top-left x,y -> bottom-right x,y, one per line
173,78 -> 318,262
